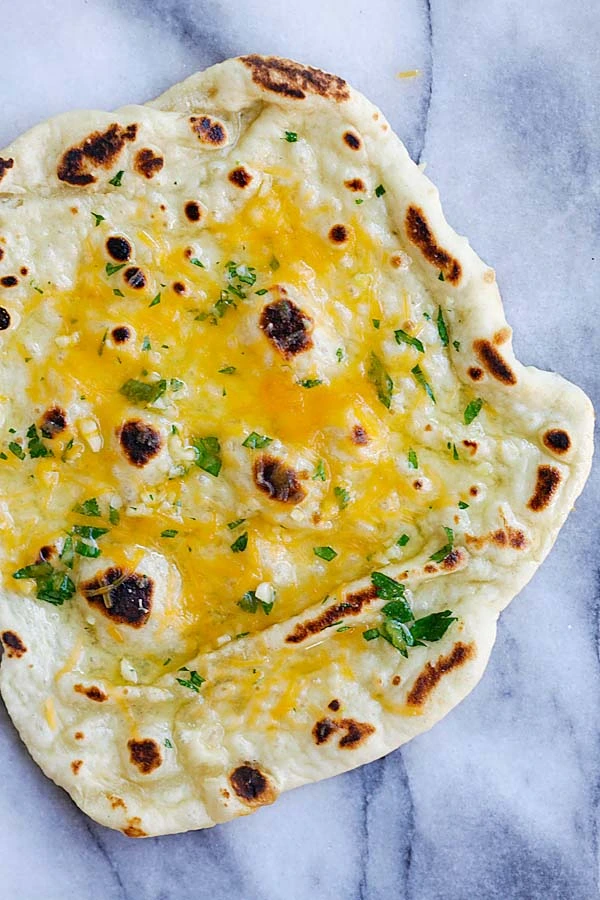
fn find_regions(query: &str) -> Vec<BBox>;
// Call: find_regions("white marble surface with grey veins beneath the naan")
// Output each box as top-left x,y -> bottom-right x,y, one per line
0,0 -> 600,900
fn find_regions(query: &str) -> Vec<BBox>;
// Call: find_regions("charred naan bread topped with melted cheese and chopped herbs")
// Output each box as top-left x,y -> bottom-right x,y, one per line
0,56 -> 593,837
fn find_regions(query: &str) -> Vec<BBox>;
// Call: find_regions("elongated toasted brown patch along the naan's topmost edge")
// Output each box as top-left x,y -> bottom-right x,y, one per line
241,54 -> 350,103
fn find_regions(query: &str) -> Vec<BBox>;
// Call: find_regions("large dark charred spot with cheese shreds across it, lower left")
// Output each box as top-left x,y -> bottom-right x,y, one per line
80,566 -> 154,628
